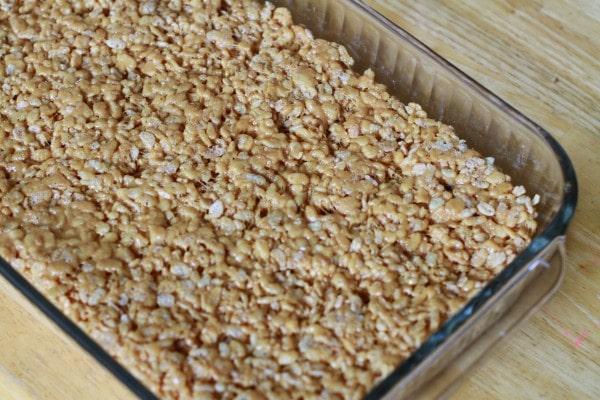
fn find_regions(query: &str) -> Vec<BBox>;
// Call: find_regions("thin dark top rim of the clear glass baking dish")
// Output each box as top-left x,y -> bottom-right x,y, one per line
0,0 -> 578,400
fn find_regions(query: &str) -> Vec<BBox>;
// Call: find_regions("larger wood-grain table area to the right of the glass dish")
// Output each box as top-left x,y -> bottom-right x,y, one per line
360,0 -> 600,399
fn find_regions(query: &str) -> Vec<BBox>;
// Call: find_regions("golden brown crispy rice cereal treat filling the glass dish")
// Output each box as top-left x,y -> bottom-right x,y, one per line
0,0 -> 536,399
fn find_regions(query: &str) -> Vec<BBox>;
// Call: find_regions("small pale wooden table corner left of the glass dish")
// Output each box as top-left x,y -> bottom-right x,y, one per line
0,278 -> 132,400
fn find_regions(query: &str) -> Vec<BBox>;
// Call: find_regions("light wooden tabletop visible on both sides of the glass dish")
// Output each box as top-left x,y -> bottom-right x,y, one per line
0,0 -> 600,400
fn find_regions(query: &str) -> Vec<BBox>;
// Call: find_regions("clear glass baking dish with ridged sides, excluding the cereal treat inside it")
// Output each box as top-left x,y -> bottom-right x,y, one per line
0,0 -> 577,399
